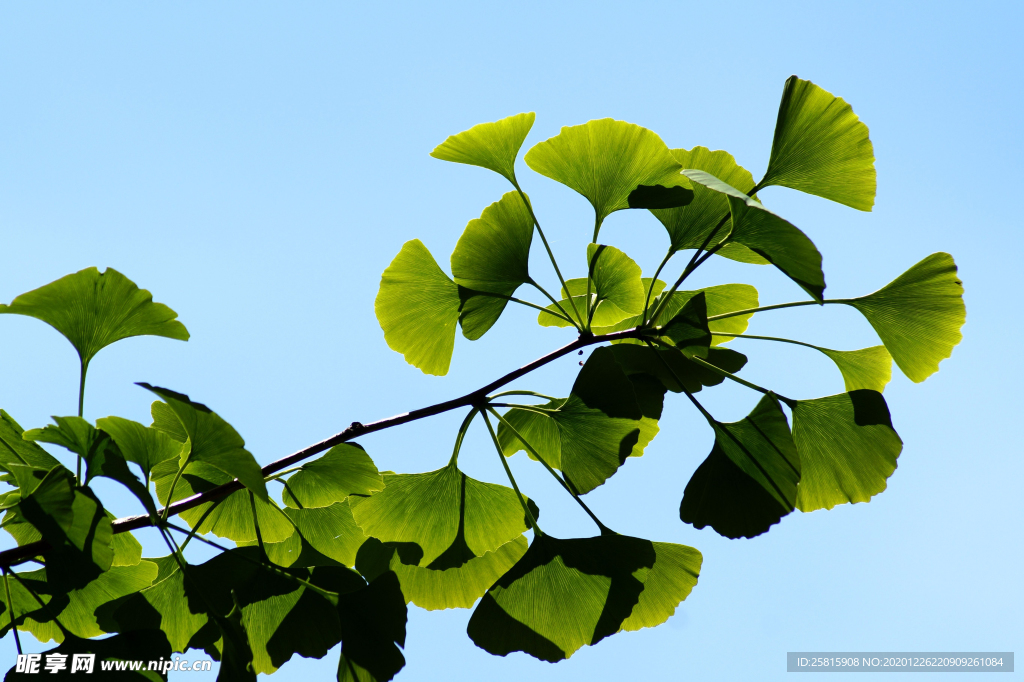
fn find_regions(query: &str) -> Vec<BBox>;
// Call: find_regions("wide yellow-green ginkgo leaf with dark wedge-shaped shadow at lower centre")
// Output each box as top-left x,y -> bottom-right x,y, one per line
349,463 -> 528,568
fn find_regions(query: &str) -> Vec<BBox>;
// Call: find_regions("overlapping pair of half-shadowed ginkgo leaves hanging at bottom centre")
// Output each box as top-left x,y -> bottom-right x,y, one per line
467,534 -> 700,663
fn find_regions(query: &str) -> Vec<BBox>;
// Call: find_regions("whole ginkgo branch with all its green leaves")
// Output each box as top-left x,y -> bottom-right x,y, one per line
0,77 -> 966,682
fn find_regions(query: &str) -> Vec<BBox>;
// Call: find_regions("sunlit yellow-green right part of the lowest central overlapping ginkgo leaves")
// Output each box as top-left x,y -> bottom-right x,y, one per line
620,543 -> 703,632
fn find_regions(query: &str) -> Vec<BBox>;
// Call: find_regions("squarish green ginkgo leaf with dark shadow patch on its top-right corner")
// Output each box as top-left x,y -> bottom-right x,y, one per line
793,389 -> 903,512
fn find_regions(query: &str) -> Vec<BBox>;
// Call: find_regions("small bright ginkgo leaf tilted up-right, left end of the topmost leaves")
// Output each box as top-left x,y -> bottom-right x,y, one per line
430,112 -> 536,184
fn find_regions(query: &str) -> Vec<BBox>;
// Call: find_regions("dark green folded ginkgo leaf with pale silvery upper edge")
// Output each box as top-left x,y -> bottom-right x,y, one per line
683,170 -> 825,302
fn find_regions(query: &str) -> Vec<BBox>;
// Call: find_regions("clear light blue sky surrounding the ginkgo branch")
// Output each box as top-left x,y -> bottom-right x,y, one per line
0,2 -> 1024,682
